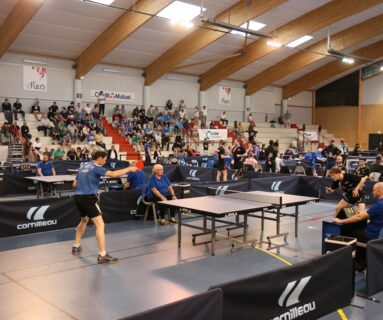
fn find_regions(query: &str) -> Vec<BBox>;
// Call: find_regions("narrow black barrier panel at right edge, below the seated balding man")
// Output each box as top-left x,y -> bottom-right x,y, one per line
366,239 -> 383,296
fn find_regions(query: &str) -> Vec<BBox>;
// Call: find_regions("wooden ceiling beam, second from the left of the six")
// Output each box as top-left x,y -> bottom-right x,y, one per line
76,0 -> 173,78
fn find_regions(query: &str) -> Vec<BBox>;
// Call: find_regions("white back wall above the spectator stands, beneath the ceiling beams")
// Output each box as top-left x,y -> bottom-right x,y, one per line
0,53 -> 314,124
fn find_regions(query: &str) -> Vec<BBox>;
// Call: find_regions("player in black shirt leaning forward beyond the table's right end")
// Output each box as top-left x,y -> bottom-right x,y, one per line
326,167 -> 368,217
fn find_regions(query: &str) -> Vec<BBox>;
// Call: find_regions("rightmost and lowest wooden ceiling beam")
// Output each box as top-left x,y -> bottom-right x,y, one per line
282,40 -> 383,99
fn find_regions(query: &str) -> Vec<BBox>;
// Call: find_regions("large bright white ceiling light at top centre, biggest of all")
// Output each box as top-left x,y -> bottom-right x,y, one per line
157,0 -> 206,24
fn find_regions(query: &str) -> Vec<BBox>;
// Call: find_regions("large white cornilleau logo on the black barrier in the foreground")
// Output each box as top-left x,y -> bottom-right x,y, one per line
272,276 -> 315,320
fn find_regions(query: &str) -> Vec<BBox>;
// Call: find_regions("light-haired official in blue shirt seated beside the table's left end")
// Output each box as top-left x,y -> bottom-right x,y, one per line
146,164 -> 177,225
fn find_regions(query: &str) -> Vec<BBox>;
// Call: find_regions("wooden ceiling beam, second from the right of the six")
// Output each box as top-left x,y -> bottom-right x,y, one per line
246,14 -> 383,95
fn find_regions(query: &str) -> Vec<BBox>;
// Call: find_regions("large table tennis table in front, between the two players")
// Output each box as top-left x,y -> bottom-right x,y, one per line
158,190 -> 319,255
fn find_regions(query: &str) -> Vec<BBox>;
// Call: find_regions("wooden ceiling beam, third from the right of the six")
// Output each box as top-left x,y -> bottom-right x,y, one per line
200,0 -> 382,91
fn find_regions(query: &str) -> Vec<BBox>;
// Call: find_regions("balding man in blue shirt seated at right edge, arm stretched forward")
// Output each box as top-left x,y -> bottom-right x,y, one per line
332,182 -> 383,271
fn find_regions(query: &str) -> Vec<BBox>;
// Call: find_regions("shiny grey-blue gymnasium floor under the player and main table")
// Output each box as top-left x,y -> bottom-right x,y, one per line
0,201 -> 383,320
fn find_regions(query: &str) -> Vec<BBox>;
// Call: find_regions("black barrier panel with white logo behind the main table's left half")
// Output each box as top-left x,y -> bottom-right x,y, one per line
190,180 -> 249,197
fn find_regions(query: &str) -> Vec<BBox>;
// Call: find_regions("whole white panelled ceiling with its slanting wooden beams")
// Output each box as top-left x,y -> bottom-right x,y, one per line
0,0 -> 383,97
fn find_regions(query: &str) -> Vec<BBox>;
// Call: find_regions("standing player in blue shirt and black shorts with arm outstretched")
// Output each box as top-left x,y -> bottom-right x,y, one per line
72,151 -> 138,263
